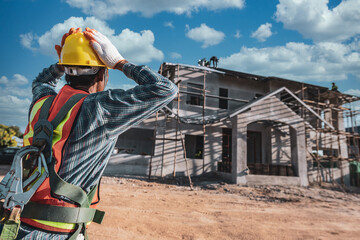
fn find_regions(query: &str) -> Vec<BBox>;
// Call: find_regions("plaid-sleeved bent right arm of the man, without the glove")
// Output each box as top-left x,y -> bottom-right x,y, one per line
83,63 -> 178,138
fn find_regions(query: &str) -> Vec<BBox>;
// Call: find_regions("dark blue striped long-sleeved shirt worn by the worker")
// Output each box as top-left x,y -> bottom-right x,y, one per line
3,63 -> 178,239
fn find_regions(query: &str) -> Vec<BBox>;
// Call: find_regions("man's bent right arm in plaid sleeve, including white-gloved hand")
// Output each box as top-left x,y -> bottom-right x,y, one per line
84,28 -> 178,138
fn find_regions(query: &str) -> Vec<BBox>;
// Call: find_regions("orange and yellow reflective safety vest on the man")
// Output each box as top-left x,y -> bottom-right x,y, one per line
21,85 -> 99,233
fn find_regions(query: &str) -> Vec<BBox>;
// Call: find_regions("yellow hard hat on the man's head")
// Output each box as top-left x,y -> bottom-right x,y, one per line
59,32 -> 106,67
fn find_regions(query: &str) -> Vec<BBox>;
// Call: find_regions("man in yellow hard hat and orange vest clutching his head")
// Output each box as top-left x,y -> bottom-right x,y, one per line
0,28 -> 178,239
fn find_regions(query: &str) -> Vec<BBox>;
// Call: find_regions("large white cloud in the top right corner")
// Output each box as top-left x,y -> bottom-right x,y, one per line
275,0 -> 360,42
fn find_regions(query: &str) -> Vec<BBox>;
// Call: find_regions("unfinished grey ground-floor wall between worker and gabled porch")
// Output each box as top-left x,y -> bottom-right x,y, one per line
105,111 -> 231,176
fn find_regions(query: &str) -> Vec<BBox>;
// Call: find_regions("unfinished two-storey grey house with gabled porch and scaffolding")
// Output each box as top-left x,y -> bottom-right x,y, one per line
106,63 -> 360,186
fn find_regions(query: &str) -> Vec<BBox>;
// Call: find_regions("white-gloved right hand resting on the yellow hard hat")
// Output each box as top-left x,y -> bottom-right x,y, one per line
84,28 -> 124,68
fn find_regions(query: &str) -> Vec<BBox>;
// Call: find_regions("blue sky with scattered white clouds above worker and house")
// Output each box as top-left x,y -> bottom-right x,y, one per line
0,0 -> 360,130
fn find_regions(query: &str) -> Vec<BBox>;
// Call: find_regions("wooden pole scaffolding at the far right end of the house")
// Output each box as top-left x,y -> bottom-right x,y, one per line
301,86 -> 360,185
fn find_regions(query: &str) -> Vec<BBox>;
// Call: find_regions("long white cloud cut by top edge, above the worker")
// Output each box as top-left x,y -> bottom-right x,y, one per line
66,0 -> 245,19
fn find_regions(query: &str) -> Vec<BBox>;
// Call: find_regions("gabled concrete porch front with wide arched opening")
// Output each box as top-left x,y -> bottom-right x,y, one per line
232,97 -> 308,186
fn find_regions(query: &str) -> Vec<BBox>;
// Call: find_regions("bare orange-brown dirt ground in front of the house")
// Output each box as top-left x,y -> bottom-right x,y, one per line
0,165 -> 360,240
